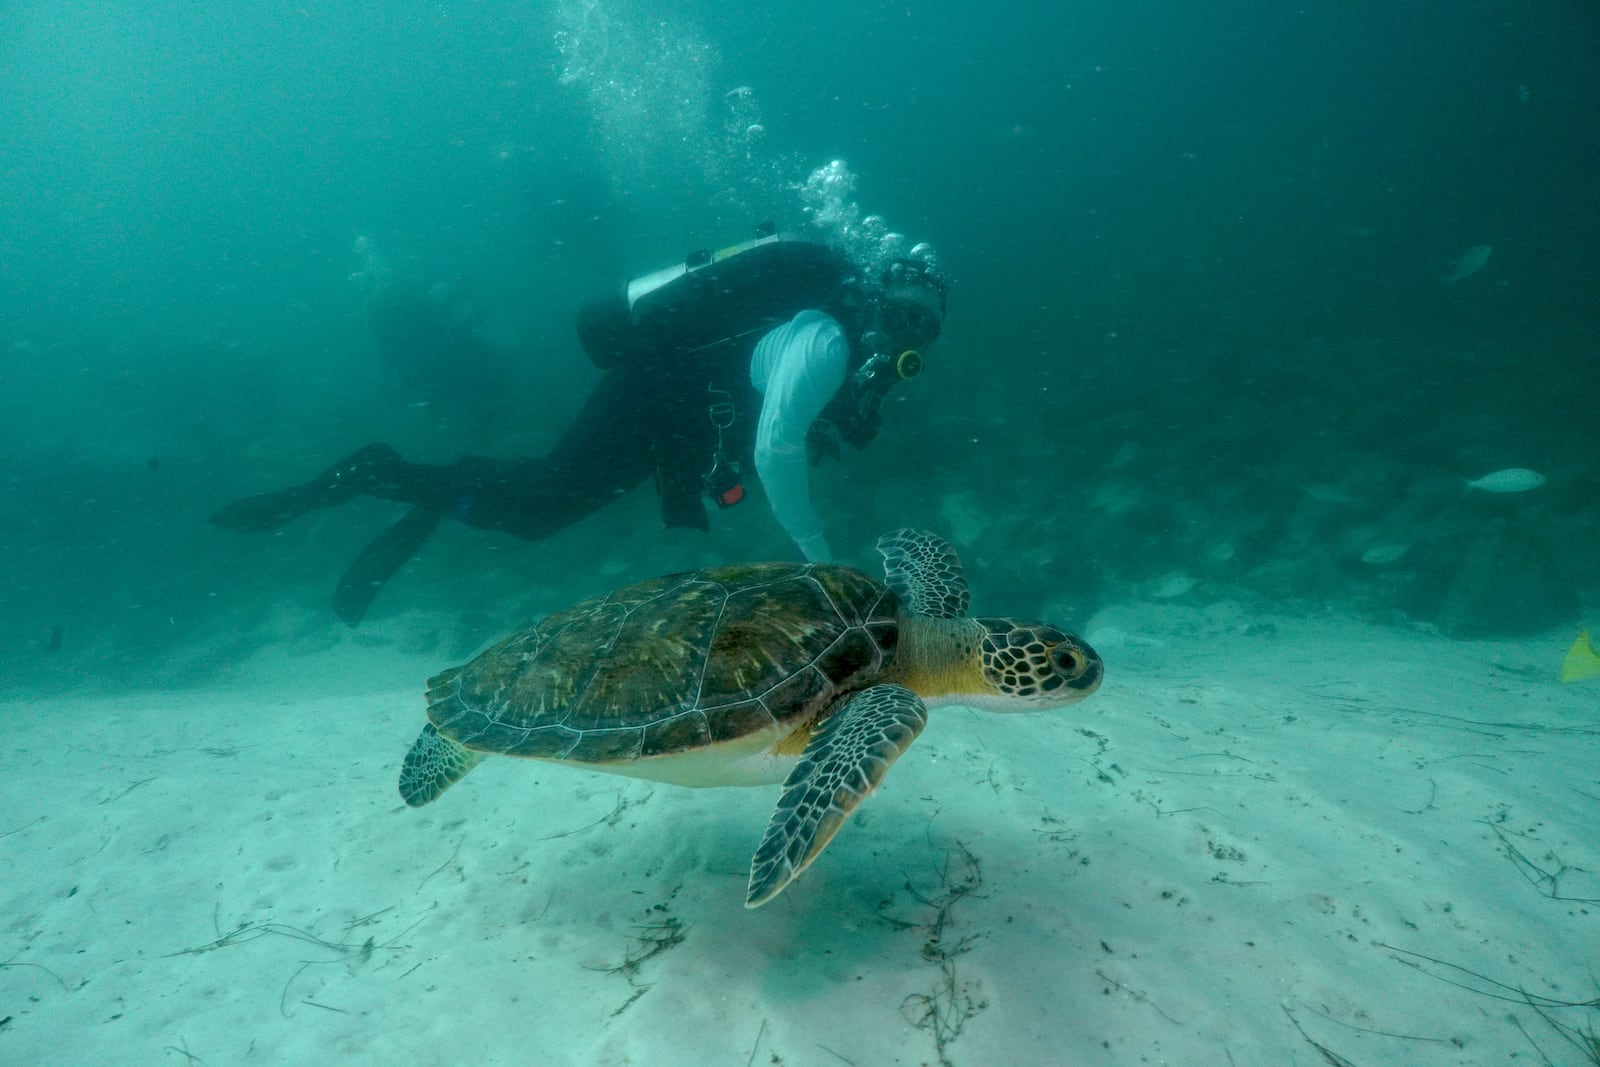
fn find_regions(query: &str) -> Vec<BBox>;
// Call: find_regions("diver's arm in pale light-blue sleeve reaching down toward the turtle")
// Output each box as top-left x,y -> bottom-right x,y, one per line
755,312 -> 850,563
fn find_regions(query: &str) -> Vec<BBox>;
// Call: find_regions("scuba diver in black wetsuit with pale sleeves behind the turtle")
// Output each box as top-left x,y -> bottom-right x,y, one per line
211,224 -> 947,627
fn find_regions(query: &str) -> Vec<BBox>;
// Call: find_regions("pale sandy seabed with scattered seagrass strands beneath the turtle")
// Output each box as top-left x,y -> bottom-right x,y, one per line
0,605 -> 1600,1067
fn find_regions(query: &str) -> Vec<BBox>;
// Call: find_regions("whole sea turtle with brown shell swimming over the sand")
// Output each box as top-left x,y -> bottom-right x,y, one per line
400,530 -> 1102,907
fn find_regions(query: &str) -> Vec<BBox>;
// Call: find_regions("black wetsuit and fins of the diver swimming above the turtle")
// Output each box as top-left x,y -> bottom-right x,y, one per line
222,242 -> 853,625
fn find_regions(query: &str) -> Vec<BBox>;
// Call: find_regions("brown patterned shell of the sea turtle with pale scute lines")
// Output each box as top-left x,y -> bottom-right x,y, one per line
427,563 -> 899,763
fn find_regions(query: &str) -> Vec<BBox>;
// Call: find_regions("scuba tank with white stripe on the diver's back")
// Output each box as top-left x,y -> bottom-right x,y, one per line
578,222 -> 856,371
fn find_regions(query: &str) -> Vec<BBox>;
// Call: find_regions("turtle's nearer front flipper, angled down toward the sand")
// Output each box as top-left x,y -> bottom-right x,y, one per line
744,685 -> 928,907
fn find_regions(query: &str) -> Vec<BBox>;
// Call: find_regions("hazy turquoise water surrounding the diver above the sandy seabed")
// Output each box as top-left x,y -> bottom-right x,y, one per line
0,0 -> 1600,1062
